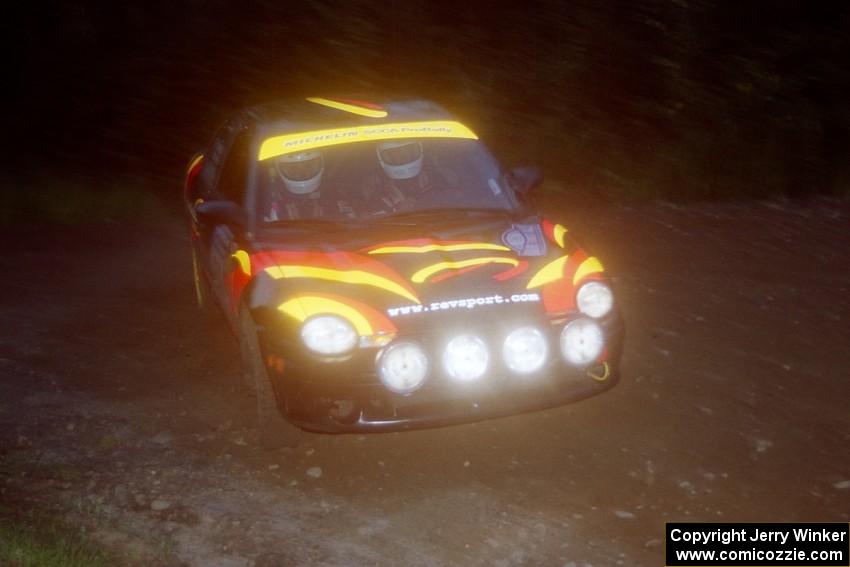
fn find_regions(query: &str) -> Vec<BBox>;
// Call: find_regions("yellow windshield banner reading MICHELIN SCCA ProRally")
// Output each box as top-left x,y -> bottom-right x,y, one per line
258,120 -> 478,161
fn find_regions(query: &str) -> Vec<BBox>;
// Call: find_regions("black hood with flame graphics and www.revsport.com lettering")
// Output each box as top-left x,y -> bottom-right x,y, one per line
232,218 -> 603,335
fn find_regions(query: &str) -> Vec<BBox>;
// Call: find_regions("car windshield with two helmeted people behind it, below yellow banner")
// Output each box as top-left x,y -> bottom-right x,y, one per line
257,138 -> 518,224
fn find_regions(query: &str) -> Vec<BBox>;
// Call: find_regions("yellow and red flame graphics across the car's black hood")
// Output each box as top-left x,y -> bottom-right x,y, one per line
228,227 -> 604,324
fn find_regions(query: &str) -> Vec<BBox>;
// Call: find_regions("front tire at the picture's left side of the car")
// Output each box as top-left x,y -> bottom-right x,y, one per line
239,307 -> 301,449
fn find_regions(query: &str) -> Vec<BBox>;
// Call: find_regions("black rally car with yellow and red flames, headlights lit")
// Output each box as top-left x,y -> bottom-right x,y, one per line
185,97 -> 623,444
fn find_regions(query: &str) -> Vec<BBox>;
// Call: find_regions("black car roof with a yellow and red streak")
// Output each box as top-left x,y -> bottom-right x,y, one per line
244,96 -> 452,134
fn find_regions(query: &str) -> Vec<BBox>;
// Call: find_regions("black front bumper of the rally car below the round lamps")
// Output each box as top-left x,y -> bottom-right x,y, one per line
260,318 -> 623,433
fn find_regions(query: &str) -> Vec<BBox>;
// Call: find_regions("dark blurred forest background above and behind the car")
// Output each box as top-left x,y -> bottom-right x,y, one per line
2,0 -> 850,219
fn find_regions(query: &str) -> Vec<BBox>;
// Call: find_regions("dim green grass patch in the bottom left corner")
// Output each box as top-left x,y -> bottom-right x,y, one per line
0,518 -> 115,567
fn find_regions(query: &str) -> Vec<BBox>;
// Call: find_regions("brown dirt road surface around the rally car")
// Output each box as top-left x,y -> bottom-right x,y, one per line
0,200 -> 850,567
